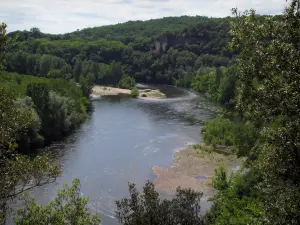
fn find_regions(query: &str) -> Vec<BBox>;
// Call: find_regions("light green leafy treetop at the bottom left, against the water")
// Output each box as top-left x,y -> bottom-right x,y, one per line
15,179 -> 101,225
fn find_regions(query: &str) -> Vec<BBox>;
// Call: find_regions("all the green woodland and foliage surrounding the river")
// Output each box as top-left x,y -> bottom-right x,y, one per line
0,0 -> 300,225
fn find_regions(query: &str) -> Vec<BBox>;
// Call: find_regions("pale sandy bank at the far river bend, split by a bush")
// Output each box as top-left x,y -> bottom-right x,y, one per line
91,85 -> 166,99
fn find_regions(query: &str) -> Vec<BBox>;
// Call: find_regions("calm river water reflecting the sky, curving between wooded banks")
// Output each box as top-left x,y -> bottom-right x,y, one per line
28,86 -> 217,225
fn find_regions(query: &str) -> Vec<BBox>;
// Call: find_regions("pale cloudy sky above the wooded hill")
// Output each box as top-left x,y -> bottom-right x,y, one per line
0,0 -> 286,34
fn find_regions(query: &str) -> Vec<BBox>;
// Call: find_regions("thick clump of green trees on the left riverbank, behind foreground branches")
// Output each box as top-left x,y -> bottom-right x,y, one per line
0,72 -> 93,148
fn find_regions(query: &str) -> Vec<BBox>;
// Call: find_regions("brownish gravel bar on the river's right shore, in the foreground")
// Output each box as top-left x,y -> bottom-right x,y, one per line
152,146 -> 241,197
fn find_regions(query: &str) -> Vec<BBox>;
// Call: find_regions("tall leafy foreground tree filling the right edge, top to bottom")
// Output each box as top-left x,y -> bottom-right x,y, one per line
231,0 -> 300,225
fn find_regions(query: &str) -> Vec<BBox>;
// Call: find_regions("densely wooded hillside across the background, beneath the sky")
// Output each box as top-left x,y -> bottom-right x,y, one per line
7,16 -> 233,86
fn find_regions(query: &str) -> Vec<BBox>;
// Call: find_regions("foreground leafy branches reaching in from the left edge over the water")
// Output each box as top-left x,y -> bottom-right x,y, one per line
0,88 -> 59,224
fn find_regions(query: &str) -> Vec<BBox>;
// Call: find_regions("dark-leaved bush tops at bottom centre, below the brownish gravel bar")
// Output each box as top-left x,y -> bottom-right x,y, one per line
116,181 -> 203,225
